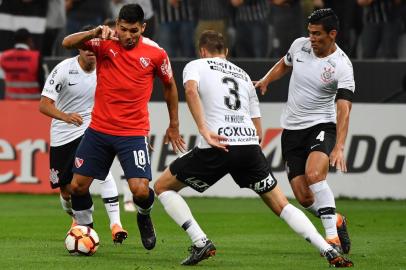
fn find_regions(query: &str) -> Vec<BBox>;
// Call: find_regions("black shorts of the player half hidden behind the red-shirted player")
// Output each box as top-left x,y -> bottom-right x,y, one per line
49,136 -> 82,188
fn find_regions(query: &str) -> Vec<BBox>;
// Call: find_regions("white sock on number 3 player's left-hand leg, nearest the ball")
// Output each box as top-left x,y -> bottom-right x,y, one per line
158,190 -> 207,247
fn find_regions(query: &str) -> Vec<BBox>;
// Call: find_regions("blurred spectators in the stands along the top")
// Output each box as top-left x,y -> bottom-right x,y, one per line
0,0 -> 406,59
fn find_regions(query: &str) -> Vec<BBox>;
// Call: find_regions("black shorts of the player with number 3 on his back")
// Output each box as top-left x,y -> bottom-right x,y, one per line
169,145 -> 277,194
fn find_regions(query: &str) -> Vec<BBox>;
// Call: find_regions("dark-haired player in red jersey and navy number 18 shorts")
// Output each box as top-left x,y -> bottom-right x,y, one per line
62,4 -> 185,249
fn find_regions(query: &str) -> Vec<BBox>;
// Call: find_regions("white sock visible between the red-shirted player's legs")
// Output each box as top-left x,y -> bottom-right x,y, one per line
97,172 -> 122,229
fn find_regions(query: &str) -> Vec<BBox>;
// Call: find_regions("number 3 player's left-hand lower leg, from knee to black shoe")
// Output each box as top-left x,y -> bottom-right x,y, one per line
154,168 -> 216,265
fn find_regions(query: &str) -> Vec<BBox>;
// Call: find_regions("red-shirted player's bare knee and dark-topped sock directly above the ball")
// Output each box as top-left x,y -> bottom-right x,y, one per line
70,173 -> 94,227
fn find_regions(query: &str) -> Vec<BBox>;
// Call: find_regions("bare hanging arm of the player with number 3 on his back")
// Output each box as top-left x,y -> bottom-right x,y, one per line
185,80 -> 228,152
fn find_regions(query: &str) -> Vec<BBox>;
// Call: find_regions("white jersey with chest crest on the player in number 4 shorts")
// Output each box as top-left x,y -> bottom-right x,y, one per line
281,38 -> 355,130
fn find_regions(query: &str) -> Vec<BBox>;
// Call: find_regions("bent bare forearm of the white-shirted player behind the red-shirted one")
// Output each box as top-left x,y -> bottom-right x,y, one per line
39,96 -> 83,126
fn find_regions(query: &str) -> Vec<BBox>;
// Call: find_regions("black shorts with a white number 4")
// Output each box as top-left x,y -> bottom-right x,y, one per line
281,123 -> 336,181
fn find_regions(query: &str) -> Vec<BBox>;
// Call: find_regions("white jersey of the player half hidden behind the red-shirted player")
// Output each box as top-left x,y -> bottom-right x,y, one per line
42,56 -> 96,146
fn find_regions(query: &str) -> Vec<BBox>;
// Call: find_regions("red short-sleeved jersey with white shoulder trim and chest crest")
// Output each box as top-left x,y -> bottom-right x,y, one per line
85,36 -> 172,136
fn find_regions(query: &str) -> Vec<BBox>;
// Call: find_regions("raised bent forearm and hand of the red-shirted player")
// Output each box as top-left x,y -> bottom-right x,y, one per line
62,25 -> 118,49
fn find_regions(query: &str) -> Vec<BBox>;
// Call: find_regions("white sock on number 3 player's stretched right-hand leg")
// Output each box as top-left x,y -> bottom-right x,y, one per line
280,204 -> 331,253
